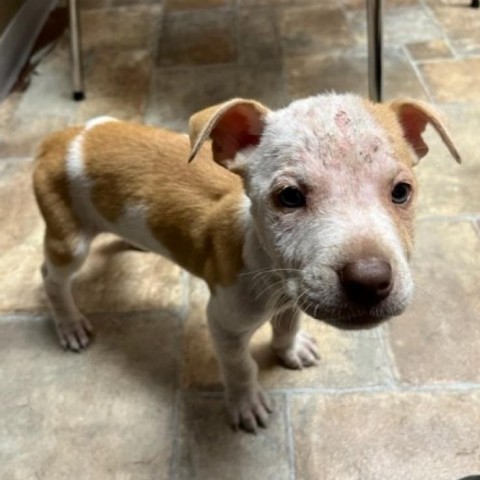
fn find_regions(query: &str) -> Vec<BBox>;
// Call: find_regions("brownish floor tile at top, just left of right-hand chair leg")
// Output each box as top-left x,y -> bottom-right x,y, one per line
279,5 -> 353,57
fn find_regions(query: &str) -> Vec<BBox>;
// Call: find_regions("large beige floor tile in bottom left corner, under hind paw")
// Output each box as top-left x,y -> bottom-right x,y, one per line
0,313 -> 178,480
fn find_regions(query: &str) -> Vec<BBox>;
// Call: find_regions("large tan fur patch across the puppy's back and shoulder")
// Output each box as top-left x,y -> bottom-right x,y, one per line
83,122 -> 244,286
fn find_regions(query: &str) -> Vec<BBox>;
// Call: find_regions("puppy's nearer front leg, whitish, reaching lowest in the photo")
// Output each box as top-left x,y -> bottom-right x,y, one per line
208,297 -> 273,433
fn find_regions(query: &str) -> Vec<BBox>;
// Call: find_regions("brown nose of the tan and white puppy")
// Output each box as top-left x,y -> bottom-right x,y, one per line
338,257 -> 393,306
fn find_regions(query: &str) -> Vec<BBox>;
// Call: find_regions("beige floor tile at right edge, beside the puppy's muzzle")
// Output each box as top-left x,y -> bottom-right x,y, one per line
390,221 -> 480,384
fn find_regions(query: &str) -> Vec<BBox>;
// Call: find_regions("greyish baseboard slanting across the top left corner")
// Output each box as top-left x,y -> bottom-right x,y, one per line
0,0 -> 58,101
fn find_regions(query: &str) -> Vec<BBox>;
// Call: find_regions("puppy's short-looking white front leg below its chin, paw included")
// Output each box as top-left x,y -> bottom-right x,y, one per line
271,308 -> 320,369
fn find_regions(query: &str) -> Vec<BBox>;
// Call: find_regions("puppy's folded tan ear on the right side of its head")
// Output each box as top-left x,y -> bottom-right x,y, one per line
389,99 -> 462,163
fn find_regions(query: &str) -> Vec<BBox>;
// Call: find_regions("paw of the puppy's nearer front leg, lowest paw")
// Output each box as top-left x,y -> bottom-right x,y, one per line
227,385 -> 273,433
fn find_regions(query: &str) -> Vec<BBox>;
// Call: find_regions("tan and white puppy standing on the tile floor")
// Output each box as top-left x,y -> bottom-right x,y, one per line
34,94 -> 460,431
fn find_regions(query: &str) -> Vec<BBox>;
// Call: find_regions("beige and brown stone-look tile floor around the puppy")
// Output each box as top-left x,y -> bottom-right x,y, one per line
0,0 -> 480,480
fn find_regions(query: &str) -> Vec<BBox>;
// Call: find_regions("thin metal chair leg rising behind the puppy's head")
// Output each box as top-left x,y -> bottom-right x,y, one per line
367,0 -> 383,102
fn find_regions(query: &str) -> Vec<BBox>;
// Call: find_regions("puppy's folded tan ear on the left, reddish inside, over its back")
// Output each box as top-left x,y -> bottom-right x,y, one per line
188,98 -> 269,170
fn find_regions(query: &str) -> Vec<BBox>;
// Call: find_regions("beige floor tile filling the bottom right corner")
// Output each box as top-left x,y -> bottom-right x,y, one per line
291,392 -> 480,480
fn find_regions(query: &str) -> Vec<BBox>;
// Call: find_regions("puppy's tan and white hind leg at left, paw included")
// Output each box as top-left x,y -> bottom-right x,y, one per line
42,230 -> 92,352
